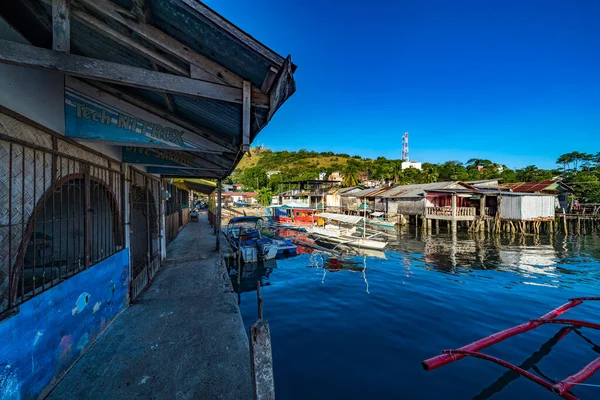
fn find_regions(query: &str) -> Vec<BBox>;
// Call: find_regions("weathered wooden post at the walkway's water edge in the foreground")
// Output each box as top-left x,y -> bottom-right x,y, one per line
250,282 -> 275,400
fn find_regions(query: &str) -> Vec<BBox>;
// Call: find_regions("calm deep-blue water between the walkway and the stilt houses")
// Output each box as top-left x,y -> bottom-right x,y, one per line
232,233 -> 600,399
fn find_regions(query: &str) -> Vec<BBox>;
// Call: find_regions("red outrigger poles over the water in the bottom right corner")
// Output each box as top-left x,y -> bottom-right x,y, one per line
422,297 -> 600,400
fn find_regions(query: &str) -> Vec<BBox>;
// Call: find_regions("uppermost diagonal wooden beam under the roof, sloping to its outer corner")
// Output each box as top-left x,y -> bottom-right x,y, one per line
79,0 -> 268,101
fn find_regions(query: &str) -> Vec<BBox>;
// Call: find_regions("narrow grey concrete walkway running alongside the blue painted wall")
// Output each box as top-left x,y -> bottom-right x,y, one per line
49,215 -> 252,400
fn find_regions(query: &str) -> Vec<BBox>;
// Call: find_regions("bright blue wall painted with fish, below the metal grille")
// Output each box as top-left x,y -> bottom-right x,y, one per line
0,249 -> 129,400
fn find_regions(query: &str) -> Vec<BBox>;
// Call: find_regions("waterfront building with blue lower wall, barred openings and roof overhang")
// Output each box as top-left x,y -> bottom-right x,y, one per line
0,0 -> 295,398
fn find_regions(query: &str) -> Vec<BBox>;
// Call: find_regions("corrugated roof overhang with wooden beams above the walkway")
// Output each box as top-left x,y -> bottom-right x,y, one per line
0,0 -> 296,178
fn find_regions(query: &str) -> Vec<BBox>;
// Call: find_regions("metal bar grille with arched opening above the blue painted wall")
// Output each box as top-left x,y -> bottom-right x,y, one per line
0,134 -> 124,315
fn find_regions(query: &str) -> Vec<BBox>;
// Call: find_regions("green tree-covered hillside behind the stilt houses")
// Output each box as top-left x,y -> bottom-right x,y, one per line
229,148 -> 600,203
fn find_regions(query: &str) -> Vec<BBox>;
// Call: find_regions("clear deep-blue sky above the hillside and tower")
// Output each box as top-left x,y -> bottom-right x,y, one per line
205,0 -> 600,168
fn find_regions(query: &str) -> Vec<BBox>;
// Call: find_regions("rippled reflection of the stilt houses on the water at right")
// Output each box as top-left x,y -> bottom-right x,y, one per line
386,231 -> 600,287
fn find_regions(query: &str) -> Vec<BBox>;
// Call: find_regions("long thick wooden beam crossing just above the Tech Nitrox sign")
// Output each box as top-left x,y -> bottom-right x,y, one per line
0,40 -> 256,104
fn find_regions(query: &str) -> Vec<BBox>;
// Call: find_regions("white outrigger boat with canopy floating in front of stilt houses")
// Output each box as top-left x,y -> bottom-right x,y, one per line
306,213 -> 387,250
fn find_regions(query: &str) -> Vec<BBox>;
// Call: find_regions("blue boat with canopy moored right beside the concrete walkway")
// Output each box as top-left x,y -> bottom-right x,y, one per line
225,216 -> 279,263
